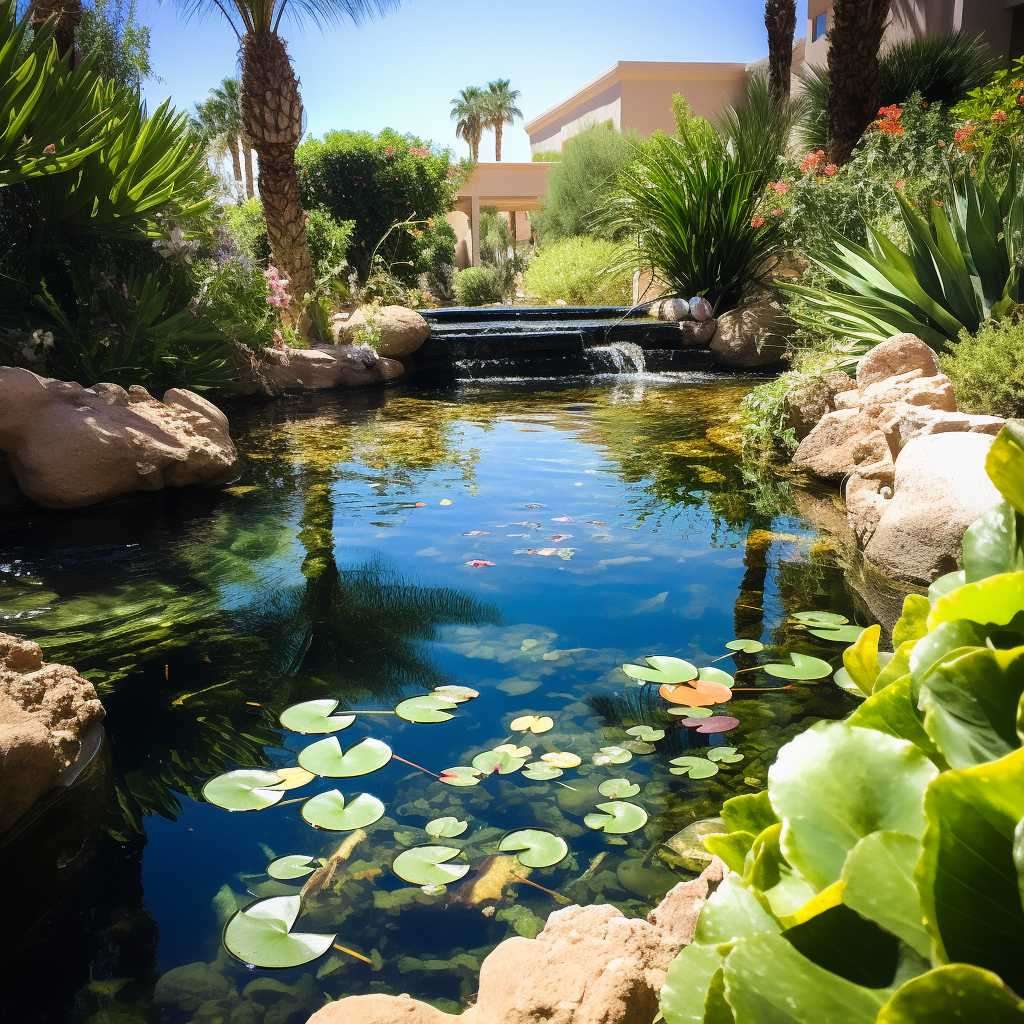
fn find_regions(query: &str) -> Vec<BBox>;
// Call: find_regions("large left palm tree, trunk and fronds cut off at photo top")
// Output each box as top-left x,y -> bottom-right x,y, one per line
179,0 -> 400,321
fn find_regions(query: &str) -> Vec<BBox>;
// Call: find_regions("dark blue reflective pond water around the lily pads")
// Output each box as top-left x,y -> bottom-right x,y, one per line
0,375 -> 854,1024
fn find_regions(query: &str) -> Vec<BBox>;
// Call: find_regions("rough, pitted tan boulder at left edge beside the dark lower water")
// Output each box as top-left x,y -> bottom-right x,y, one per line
0,633 -> 103,833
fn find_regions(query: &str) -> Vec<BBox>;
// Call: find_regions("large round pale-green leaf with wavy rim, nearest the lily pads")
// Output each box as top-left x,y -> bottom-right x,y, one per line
768,722 -> 937,889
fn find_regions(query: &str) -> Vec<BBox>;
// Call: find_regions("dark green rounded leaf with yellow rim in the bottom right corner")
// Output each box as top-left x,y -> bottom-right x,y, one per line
878,964 -> 1024,1024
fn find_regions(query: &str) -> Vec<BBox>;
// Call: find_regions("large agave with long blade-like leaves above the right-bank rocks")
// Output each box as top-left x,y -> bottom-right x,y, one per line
779,160 -> 1024,348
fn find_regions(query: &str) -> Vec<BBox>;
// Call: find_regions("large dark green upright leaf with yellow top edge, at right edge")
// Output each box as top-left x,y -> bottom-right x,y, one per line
916,750 -> 1024,992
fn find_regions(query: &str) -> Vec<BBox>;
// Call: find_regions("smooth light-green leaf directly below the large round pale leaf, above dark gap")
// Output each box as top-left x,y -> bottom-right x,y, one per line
843,831 -> 932,957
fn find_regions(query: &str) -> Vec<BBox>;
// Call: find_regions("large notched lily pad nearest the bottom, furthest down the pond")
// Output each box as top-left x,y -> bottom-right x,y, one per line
223,896 -> 337,968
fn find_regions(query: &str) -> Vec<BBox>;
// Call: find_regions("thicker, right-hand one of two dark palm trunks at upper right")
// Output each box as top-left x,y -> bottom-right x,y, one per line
826,0 -> 890,164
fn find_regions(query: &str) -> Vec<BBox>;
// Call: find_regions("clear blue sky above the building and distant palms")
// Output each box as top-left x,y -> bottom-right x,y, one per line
139,0 -> 807,160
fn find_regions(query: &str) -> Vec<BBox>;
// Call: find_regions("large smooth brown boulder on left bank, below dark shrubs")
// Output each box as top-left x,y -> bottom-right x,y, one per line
0,367 -> 237,508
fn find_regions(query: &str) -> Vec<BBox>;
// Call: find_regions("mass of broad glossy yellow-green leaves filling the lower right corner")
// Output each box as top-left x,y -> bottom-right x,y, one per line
662,425 -> 1024,1024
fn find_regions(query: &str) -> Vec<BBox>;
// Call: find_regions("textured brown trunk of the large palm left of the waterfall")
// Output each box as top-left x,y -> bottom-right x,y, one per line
242,35 -> 313,322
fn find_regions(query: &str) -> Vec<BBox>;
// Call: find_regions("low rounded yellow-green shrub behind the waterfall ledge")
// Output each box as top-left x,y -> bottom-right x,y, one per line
523,238 -> 633,306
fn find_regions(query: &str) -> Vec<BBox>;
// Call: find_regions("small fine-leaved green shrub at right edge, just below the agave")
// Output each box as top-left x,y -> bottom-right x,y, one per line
940,315 -> 1024,419
